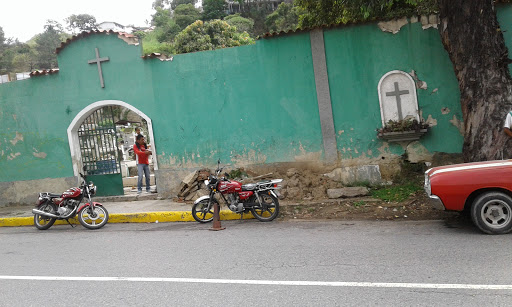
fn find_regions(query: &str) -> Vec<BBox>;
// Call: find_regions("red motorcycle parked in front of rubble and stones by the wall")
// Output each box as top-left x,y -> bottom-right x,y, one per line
192,160 -> 283,223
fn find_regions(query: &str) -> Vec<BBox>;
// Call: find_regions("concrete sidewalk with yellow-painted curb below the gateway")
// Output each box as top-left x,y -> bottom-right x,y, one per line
0,193 -> 252,227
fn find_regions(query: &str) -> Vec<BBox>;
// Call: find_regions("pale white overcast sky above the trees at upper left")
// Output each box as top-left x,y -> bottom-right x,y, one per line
0,0 -> 154,42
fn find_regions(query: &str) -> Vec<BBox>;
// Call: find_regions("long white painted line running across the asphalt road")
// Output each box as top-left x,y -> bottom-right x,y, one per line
0,275 -> 512,290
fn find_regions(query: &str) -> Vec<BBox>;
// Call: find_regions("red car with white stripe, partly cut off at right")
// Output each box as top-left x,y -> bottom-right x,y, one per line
425,160 -> 512,234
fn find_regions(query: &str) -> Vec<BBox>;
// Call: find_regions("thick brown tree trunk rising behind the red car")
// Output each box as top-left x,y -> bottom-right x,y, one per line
439,0 -> 512,162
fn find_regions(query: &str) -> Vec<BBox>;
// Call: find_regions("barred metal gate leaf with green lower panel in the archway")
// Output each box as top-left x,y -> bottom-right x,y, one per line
78,106 -> 123,196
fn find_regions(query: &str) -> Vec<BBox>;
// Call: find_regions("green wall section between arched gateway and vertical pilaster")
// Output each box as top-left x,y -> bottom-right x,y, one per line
148,34 -> 322,168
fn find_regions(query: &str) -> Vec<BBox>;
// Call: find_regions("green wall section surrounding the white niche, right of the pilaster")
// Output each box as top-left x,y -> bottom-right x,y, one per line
324,23 -> 463,159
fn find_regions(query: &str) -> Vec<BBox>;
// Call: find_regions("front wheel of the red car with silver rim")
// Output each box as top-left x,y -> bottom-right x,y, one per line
471,192 -> 512,234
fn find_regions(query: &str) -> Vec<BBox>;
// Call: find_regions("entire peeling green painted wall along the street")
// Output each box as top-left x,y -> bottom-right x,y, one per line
20,5 -> 512,182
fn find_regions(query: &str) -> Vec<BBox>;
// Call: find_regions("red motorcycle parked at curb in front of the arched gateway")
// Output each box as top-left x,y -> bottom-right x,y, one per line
32,167 -> 108,230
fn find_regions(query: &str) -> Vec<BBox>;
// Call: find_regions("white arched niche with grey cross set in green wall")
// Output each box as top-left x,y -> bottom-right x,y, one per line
378,70 -> 419,127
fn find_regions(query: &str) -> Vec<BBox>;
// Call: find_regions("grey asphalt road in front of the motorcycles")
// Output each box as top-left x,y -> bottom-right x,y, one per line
0,220 -> 512,306
